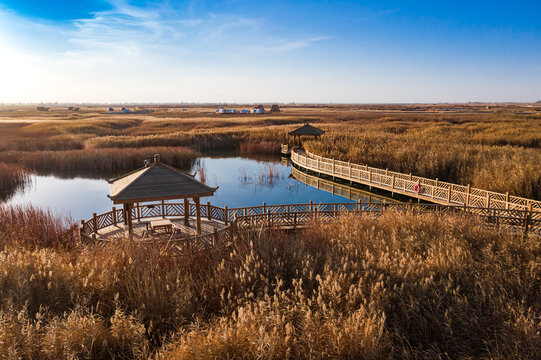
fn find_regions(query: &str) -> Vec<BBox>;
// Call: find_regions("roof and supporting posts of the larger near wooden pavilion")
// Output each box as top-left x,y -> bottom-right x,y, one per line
107,154 -> 218,237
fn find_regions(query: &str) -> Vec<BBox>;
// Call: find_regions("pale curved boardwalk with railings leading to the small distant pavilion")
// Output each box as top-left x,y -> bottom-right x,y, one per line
291,150 -> 541,211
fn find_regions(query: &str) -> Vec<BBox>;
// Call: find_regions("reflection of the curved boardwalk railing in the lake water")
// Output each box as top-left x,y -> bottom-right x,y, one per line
291,166 -> 398,203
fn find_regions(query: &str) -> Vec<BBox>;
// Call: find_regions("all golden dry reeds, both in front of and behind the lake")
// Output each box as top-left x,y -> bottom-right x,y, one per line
0,105 -> 541,360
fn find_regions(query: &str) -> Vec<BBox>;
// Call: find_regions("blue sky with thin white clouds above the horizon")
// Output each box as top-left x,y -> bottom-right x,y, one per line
0,0 -> 541,103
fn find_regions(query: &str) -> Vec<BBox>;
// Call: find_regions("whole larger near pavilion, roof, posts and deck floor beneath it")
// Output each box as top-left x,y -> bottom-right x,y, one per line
104,155 -> 223,237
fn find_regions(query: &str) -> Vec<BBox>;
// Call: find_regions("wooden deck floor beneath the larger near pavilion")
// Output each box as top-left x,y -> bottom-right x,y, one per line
98,217 -> 226,240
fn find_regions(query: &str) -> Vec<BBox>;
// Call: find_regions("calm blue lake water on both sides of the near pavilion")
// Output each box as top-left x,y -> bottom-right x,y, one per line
7,157 -> 382,220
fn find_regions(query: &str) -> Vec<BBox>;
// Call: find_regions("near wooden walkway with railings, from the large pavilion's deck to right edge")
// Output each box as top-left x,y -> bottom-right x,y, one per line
80,202 -> 541,242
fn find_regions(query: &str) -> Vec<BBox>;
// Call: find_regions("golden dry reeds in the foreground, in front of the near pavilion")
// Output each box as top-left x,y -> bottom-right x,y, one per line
0,207 -> 541,359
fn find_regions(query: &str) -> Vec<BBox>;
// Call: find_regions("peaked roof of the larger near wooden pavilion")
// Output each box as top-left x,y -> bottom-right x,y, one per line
108,162 -> 218,204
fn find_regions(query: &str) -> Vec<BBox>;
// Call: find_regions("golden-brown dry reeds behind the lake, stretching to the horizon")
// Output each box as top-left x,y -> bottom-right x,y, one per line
0,104 -> 541,200
